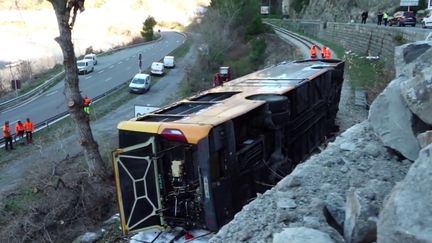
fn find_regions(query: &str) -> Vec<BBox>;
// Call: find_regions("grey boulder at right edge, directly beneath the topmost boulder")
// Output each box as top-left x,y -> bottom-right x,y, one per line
401,66 -> 432,125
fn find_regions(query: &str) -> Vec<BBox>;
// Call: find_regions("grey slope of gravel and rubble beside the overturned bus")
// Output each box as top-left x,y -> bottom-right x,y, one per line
210,121 -> 411,242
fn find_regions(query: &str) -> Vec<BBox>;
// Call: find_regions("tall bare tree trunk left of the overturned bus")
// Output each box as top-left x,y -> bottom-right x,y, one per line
48,0 -> 107,178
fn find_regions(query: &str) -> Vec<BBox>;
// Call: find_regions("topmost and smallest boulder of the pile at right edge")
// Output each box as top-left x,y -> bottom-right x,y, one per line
395,41 -> 432,78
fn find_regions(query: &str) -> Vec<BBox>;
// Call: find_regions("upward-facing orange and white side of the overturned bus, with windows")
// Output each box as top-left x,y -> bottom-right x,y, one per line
118,60 -> 342,141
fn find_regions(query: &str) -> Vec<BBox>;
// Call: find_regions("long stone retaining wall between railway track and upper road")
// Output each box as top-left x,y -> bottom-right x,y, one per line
280,20 -> 430,68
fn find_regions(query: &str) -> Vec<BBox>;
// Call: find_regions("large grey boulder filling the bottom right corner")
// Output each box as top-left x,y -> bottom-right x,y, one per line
378,145 -> 432,243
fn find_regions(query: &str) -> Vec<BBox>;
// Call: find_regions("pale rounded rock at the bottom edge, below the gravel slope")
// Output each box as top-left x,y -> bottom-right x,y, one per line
273,227 -> 334,243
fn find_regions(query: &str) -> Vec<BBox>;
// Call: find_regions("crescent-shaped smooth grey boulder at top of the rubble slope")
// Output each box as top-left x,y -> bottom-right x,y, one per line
368,77 -> 420,161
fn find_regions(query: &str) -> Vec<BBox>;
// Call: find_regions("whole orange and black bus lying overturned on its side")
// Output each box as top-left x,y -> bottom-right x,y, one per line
113,60 -> 344,234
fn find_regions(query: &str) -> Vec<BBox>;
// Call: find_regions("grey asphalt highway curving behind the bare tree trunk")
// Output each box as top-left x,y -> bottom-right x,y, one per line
0,32 -> 185,137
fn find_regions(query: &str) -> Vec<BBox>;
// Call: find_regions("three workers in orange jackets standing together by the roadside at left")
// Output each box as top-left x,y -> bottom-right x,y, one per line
3,118 -> 34,150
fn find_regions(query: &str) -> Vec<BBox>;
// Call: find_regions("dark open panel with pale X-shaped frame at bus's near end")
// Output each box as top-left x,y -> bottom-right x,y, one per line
112,137 -> 164,234
